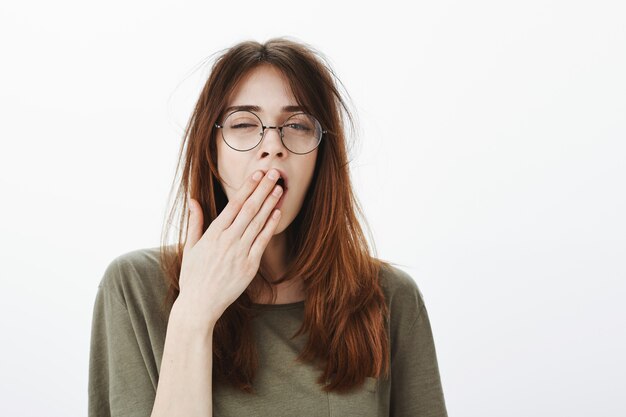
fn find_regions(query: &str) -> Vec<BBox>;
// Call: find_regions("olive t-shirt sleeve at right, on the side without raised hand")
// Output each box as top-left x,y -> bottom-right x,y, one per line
390,290 -> 448,417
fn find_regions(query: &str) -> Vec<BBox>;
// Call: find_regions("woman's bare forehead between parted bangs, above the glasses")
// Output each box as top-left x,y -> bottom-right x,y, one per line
225,64 -> 298,114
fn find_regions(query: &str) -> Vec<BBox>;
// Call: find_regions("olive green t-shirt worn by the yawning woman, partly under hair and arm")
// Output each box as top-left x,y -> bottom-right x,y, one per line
88,247 -> 447,417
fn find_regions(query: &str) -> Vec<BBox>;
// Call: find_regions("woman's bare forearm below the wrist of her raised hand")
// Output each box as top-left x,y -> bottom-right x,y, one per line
151,311 -> 214,417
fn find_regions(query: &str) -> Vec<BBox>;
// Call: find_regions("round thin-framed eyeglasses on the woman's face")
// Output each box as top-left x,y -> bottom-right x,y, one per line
215,110 -> 327,155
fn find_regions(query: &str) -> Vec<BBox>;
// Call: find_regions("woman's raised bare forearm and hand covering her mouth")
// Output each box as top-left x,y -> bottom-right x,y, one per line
152,169 -> 282,417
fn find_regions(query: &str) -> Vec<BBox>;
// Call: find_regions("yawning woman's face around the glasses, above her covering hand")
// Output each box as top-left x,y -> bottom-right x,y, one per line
216,64 -> 319,234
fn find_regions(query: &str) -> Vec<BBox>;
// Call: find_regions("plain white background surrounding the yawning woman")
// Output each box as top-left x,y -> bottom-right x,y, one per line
0,0 -> 626,417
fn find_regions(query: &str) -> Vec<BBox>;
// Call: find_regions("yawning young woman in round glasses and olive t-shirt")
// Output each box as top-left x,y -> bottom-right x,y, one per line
89,38 -> 447,417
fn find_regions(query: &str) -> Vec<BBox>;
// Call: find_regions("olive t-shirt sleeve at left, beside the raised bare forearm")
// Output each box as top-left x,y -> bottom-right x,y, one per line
88,261 -> 156,417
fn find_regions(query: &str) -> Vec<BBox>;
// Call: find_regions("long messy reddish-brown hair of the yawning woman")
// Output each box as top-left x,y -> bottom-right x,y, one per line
161,37 -> 390,393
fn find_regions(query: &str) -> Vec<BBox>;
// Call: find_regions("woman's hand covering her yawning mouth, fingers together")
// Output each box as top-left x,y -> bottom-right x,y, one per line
175,169 -> 283,329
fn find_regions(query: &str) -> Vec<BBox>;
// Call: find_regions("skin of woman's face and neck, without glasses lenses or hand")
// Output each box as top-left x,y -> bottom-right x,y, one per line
217,64 -> 319,304
